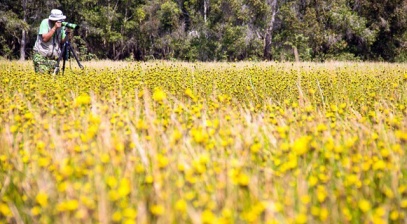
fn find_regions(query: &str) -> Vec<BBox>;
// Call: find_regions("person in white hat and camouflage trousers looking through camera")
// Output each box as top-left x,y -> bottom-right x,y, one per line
33,9 -> 66,73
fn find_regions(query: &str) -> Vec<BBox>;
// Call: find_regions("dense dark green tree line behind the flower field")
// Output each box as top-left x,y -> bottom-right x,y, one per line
0,0 -> 407,62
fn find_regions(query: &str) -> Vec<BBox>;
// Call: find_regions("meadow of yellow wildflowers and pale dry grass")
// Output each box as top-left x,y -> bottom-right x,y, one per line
0,61 -> 407,224
